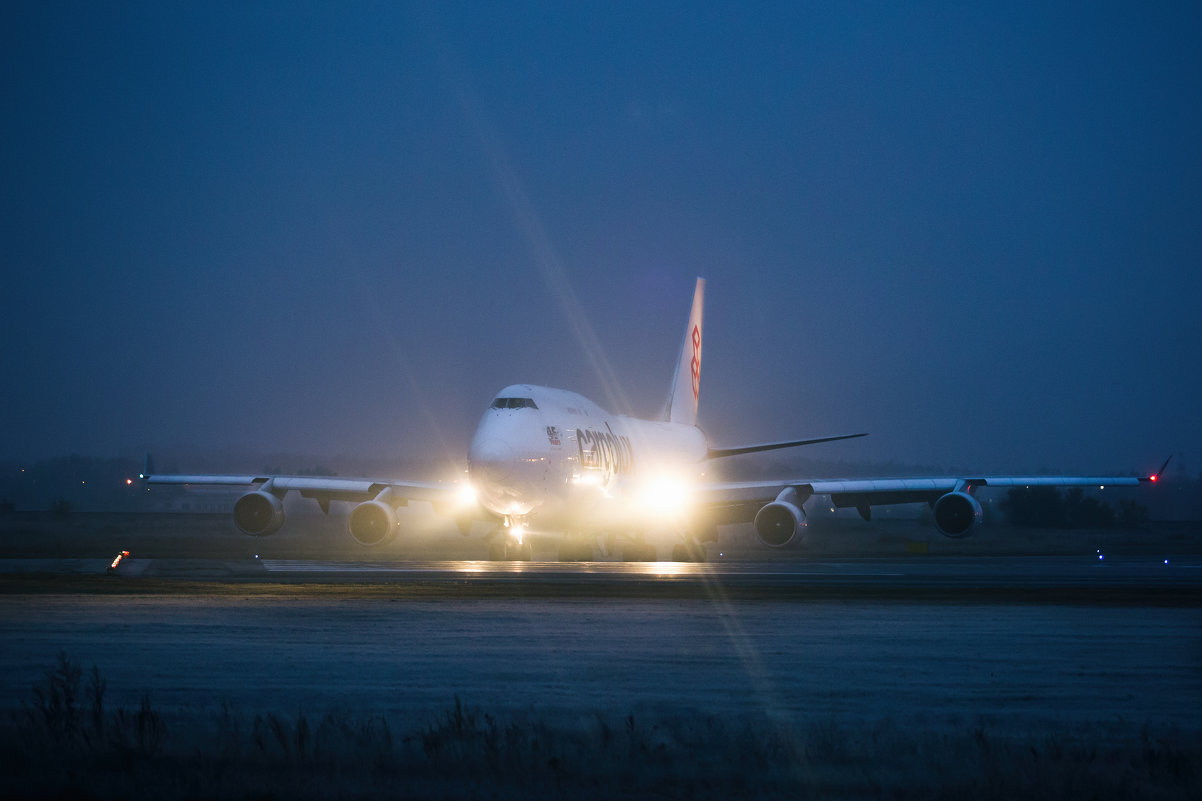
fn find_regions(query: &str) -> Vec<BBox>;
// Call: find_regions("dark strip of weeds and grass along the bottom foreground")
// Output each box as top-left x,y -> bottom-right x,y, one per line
0,654 -> 1202,801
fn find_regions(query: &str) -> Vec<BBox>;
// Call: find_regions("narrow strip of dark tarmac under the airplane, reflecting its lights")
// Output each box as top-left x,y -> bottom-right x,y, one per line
0,552 -> 1202,606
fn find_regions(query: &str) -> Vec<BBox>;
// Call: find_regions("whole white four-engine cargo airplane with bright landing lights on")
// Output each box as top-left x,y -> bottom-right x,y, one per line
142,278 -> 1164,560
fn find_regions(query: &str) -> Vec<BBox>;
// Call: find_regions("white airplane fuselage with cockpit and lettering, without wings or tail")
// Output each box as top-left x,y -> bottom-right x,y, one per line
468,384 -> 707,529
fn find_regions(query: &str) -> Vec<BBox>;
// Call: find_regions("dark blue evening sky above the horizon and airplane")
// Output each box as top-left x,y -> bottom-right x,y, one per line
0,2 -> 1202,470
